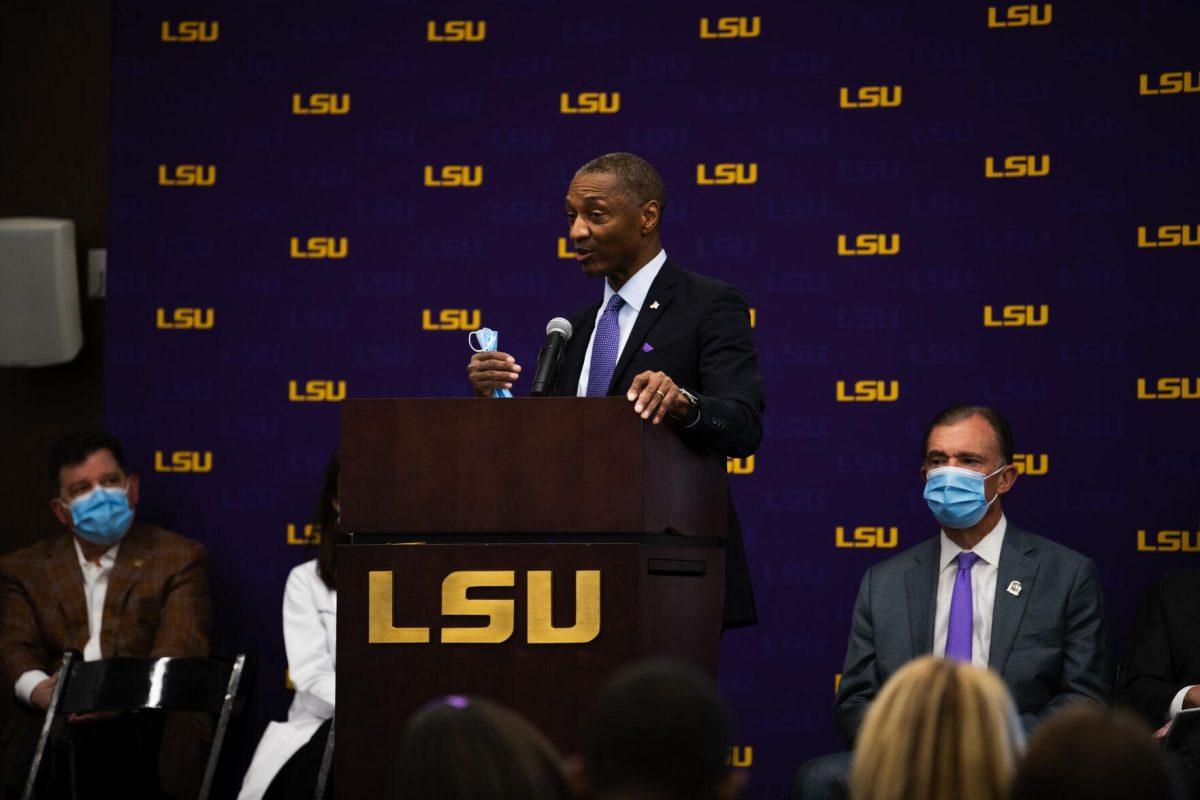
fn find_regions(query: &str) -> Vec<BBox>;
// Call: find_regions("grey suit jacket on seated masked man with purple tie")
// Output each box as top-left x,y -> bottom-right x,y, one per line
835,523 -> 1112,746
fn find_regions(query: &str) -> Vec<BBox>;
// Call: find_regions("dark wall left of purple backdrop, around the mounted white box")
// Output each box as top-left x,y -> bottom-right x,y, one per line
0,1 -> 109,553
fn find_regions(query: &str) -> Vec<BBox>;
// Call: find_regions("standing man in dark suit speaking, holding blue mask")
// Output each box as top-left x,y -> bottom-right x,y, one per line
467,152 -> 764,627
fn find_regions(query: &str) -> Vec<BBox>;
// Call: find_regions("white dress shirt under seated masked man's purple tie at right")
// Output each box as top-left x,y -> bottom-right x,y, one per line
934,515 -> 1008,667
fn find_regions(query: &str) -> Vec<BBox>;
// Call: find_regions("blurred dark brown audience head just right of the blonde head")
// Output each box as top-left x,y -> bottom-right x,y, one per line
1013,705 -> 1172,800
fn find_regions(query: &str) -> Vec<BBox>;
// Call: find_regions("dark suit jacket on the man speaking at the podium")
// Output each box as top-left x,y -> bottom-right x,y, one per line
550,259 -> 764,627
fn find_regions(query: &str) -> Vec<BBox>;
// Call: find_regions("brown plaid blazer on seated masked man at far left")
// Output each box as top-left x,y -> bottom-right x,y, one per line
0,524 -> 212,795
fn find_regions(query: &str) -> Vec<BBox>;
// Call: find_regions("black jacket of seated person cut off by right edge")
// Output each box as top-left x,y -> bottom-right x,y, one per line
1117,570 -> 1200,728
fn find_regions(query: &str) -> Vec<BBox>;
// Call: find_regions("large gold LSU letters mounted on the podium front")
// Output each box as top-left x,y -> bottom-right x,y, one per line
367,570 -> 600,644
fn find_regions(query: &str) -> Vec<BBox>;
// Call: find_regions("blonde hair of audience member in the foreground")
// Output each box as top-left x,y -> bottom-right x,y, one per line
851,656 -> 1025,800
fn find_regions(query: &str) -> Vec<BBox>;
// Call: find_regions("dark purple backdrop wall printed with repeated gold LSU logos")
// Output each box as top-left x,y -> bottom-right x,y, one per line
107,0 -> 1200,798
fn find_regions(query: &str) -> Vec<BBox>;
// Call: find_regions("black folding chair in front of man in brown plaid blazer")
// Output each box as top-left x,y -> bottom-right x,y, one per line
22,650 -> 250,800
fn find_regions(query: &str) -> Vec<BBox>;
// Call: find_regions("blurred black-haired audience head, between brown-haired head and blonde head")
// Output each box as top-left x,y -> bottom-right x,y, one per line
576,661 -> 740,800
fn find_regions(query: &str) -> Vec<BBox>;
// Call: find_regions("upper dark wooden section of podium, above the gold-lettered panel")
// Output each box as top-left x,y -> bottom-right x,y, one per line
340,397 -> 728,540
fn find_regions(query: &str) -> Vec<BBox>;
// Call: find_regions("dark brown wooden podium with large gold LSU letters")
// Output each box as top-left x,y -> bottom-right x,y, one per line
335,397 -> 728,799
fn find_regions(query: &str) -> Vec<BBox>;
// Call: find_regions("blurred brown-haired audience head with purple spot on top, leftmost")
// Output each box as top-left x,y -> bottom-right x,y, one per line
396,696 -> 570,800
